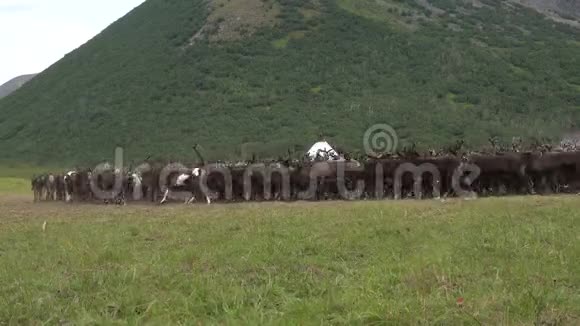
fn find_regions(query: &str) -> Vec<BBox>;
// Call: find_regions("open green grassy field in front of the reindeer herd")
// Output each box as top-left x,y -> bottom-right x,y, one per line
0,188 -> 580,325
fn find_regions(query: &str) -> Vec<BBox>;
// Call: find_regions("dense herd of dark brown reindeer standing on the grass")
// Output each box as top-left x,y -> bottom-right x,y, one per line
31,142 -> 580,204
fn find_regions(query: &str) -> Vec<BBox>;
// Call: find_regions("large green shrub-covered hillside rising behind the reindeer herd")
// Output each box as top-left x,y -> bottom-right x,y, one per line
0,0 -> 580,163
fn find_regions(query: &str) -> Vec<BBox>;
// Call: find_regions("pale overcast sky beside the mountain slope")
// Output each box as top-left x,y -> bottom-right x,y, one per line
0,0 -> 144,85
